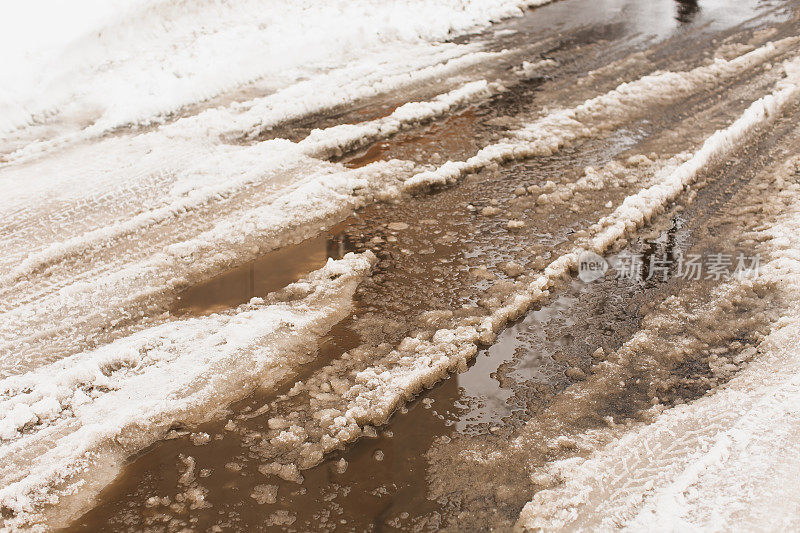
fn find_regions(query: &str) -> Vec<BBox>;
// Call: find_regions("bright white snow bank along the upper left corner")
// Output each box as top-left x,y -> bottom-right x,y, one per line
0,0 -> 548,142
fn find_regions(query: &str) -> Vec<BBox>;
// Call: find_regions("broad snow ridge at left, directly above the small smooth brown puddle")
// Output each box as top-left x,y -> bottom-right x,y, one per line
0,161 -> 409,376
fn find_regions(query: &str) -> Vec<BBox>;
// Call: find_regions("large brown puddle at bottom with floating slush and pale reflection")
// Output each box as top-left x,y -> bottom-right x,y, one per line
70,239 -> 688,531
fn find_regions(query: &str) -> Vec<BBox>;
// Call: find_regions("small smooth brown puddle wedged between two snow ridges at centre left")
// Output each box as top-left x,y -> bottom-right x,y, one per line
171,226 -> 353,315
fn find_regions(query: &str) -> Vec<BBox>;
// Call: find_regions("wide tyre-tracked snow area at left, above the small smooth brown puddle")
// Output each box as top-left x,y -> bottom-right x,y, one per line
0,66 -> 516,375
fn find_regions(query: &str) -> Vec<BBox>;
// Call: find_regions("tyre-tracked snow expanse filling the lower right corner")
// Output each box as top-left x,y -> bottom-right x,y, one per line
517,158 -> 800,531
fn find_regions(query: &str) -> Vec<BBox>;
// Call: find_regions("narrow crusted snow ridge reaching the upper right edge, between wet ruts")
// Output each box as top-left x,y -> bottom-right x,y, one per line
404,37 -> 798,191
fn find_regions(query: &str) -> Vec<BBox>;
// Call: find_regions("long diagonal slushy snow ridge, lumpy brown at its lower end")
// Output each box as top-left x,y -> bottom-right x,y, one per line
250,57 -> 800,478
